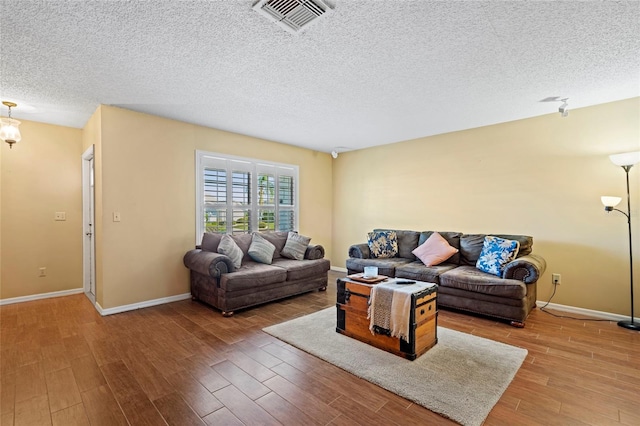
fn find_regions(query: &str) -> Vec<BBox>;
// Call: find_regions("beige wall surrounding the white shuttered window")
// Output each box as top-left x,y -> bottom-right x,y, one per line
97,106 -> 332,308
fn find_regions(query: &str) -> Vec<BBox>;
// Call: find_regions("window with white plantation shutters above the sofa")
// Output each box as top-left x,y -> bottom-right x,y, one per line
196,151 -> 298,244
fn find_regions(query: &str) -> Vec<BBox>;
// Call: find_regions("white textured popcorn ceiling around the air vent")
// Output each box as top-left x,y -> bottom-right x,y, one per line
0,0 -> 640,152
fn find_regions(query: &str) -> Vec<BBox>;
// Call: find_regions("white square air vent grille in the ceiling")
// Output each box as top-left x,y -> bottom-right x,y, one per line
253,0 -> 333,34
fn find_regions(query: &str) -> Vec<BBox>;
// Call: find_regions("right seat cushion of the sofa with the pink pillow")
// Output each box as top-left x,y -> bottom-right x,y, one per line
440,266 -> 527,299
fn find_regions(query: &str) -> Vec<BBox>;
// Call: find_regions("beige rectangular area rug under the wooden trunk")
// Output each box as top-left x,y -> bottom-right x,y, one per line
264,308 -> 527,426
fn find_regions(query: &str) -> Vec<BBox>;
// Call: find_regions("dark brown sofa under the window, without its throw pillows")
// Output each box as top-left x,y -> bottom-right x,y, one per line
183,232 -> 330,316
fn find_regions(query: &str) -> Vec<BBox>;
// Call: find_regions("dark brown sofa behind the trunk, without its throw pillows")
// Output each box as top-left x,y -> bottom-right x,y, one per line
347,230 -> 546,327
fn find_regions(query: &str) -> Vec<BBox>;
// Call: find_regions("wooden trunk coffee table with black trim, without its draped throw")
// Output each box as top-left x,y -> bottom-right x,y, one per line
336,278 -> 438,360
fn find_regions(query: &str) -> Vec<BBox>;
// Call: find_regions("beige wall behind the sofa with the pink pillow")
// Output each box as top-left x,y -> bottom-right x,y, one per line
333,98 -> 640,315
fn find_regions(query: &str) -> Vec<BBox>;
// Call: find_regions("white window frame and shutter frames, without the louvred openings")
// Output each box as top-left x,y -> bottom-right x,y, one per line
195,150 -> 300,244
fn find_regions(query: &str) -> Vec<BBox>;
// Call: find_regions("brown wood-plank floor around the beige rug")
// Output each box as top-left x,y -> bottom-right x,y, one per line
0,272 -> 640,426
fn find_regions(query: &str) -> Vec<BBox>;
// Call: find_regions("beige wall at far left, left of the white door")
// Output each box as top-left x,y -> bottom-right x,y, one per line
0,120 -> 82,299
